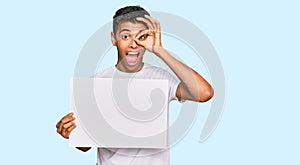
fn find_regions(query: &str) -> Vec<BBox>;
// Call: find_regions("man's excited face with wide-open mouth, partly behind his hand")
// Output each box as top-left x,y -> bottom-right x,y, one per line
111,21 -> 147,72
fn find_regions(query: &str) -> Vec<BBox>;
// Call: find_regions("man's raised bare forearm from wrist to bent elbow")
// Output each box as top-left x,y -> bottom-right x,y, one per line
155,48 -> 213,102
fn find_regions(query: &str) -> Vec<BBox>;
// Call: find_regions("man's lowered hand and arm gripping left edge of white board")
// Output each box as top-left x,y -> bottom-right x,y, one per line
56,112 -> 91,152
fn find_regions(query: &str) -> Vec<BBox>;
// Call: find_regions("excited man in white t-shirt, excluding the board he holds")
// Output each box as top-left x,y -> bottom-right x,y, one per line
56,6 -> 213,165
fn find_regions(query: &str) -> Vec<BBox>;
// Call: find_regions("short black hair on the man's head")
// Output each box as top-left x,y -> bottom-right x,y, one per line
113,5 -> 150,34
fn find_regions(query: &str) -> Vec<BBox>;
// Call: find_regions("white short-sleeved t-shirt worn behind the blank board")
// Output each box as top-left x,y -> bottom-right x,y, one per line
95,64 -> 180,165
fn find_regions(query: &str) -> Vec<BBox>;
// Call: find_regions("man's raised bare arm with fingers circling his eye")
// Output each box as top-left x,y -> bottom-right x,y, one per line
135,16 -> 214,102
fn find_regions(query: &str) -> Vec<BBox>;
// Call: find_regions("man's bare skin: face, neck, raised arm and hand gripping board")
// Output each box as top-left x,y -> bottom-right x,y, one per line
56,16 -> 214,152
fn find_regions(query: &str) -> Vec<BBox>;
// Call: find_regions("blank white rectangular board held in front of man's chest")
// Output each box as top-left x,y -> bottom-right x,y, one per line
69,78 -> 168,148
